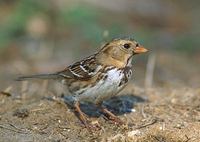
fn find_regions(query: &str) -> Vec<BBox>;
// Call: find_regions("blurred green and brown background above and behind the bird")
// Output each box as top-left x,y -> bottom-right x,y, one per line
0,0 -> 200,89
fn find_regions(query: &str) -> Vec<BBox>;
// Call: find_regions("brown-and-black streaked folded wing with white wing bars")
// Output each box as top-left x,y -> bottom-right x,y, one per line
58,56 -> 102,80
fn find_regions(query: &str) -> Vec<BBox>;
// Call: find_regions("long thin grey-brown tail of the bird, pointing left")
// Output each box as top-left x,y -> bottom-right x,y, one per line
15,73 -> 60,81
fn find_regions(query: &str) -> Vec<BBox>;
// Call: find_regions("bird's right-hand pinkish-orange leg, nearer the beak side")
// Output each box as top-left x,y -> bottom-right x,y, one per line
101,107 -> 124,125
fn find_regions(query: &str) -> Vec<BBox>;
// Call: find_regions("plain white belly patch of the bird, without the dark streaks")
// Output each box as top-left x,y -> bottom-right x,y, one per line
77,69 -> 125,103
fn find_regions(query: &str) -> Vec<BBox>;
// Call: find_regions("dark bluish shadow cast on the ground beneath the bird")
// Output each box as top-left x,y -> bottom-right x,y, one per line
63,94 -> 146,117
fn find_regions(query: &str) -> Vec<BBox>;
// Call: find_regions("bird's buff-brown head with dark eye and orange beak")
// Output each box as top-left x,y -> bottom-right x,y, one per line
97,39 -> 148,67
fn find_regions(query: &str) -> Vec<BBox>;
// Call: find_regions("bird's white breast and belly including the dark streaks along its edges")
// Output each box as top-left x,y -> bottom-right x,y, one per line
76,66 -> 132,103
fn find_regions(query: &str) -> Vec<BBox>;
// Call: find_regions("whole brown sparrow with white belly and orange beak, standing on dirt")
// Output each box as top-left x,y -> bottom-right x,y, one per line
17,38 -> 148,128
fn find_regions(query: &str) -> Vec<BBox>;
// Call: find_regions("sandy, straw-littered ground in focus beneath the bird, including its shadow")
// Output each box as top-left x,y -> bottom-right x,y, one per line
0,85 -> 200,142
